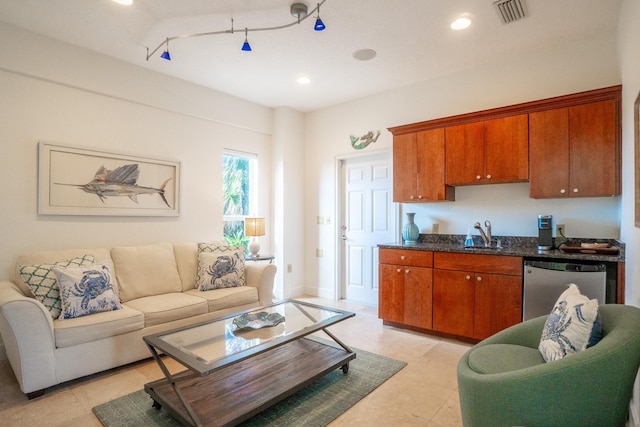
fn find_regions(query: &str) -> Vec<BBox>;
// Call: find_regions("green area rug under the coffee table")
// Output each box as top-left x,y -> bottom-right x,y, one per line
93,349 -> 406,427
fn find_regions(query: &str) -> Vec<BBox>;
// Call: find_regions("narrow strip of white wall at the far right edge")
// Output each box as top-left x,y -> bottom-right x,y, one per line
618,0 -> 640,426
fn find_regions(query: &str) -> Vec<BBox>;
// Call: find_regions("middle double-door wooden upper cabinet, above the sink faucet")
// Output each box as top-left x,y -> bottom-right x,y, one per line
445,114 -> 529,185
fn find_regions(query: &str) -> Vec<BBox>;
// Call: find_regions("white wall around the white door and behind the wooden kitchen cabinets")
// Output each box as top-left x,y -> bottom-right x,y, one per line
305,33 -> 626,297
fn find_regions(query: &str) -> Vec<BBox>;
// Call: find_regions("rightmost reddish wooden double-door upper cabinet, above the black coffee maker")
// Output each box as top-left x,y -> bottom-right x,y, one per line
529,100 -> 620,198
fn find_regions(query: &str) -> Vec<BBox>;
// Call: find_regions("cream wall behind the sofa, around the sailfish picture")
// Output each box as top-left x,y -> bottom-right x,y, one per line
0,25 -> 273,284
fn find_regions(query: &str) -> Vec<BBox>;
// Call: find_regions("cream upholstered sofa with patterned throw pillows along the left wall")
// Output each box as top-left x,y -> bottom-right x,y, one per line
0,243 -> 276,398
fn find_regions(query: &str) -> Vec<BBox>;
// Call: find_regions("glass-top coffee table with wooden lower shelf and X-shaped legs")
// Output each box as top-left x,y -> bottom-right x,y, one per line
143,300 -> 356,426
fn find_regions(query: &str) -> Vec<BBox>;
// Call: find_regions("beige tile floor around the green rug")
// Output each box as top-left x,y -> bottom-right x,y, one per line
0,297 -> 470,427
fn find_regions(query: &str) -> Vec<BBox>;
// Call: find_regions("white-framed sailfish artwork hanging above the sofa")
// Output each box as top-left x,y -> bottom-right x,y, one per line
38,142 -> 180,216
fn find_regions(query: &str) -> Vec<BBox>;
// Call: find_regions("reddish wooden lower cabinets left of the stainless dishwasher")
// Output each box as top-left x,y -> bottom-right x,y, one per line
378,248 -> 523,340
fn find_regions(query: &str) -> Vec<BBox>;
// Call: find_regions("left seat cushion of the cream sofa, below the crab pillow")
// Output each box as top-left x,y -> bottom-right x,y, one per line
53,306 -> 144,348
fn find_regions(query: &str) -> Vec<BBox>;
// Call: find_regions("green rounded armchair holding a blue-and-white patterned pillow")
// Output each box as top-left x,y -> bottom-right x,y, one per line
458,304 -> 640,427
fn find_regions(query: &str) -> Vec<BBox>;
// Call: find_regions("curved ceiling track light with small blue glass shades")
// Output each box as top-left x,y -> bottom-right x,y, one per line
147,0 -> 327,61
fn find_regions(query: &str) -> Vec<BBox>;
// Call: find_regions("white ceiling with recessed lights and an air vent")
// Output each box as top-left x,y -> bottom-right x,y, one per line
0,0 -> 622,112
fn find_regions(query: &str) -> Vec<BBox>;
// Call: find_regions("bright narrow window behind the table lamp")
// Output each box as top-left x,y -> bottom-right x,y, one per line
222,151 -> 258,246
